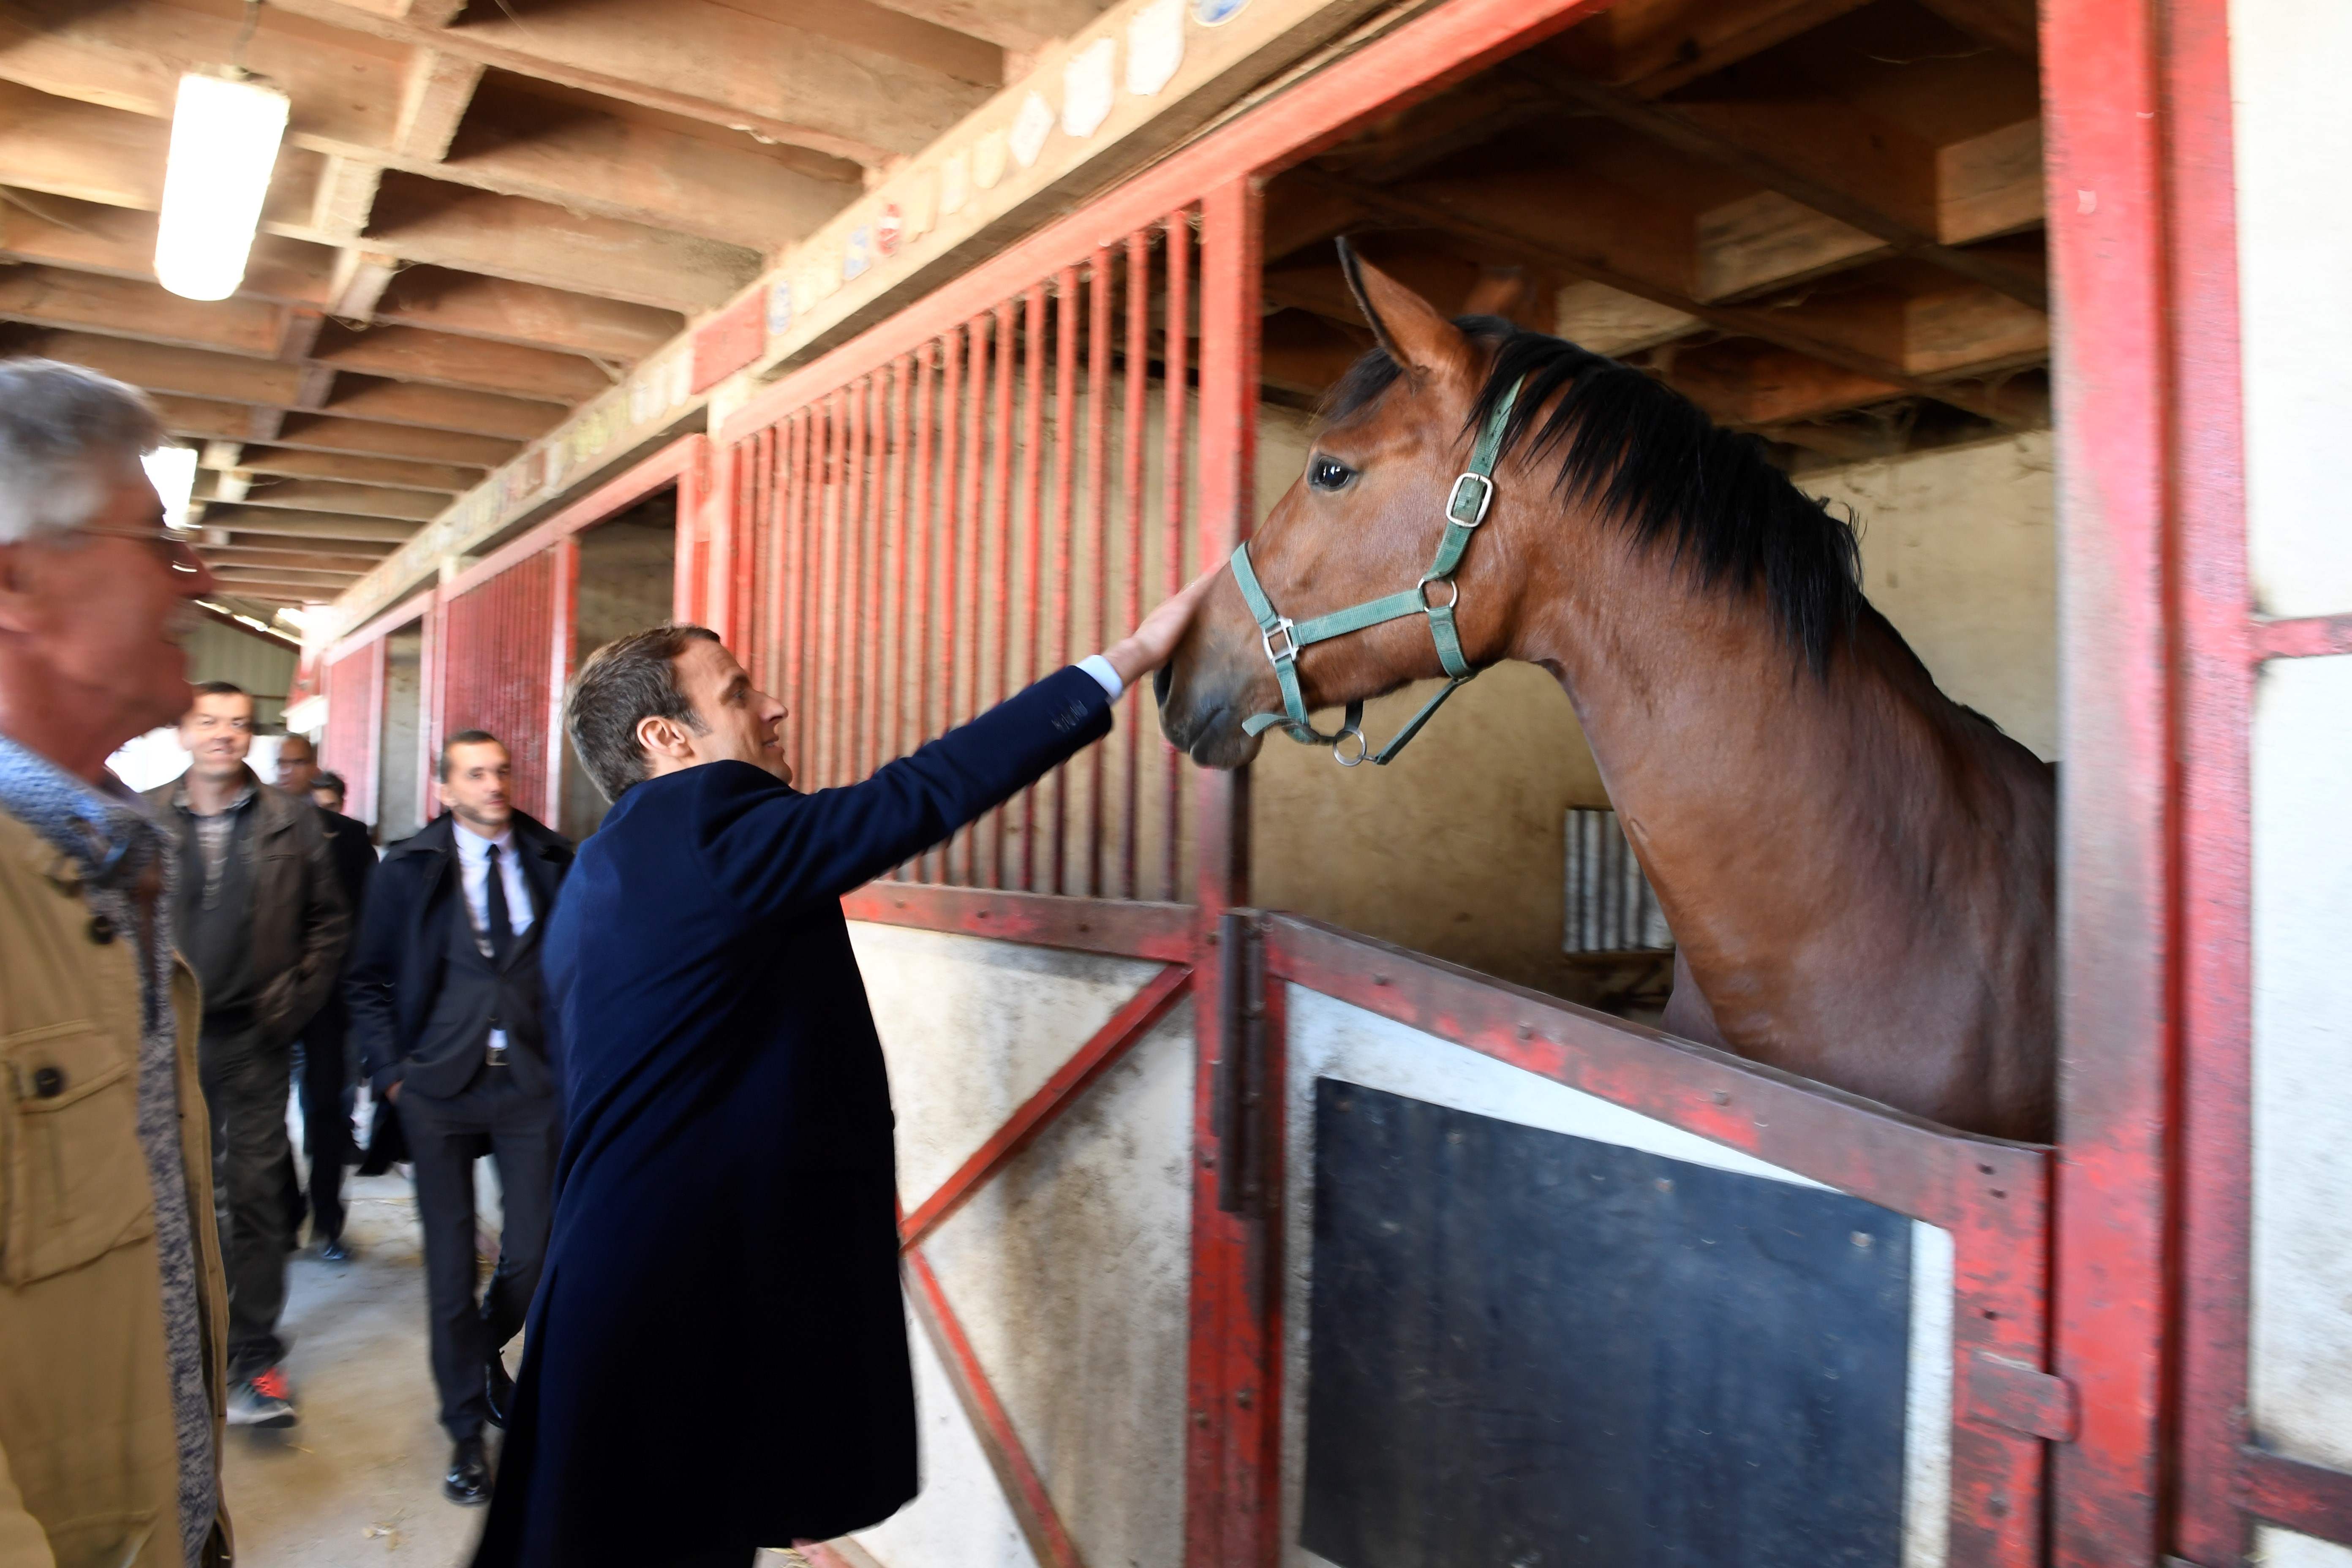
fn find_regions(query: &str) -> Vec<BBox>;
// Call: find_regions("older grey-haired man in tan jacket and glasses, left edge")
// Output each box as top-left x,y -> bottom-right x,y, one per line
0,359 -> 228,1568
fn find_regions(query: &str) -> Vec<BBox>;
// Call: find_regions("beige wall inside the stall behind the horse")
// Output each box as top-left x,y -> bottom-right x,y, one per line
1251,407 -> 2058,997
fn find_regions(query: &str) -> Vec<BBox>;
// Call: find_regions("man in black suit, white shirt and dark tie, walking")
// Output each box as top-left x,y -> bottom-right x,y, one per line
346,729 -> 572,1505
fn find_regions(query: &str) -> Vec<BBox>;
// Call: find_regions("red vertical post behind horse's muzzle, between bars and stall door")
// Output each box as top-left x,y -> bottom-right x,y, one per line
1185,176 -> 1284,1568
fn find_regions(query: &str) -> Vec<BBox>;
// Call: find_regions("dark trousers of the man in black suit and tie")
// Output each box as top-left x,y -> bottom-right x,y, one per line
400,1067 -> 562,1439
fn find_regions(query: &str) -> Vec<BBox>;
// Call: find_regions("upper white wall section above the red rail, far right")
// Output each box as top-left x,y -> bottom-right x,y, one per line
2230,0 -> 2352,616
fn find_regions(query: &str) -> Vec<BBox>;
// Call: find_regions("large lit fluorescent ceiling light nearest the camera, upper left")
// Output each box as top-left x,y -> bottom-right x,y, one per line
155,71 -> 287,299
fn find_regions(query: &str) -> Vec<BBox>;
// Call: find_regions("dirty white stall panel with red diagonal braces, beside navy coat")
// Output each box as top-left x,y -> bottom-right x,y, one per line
852,924 -> 1192,1568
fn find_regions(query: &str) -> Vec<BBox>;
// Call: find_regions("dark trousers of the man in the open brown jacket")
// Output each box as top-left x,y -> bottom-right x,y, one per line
195,1027 -> 294,1377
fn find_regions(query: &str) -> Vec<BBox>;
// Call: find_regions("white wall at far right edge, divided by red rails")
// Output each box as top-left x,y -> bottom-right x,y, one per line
2230,0 -> 2352,1495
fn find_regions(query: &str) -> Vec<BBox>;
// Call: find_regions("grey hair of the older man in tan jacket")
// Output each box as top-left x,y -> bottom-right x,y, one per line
0,359 -> 165,545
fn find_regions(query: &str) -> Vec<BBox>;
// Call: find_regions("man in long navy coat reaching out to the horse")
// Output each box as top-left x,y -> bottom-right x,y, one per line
473,574 -> 1214,1568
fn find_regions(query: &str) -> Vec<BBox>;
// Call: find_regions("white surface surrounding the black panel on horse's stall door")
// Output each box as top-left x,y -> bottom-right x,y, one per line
1282,985 -> 1952,1568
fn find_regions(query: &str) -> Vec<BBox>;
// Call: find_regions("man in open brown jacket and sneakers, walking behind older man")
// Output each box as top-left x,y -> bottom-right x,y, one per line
146,682 -> 351,1427
